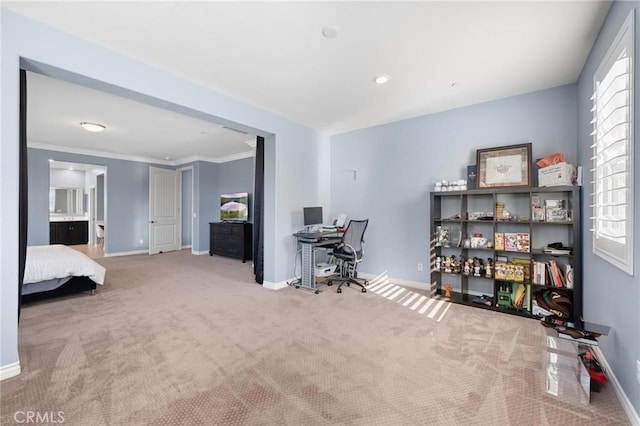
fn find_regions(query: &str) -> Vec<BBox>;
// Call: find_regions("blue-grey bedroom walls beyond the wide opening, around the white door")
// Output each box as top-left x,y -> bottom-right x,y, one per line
28,148 -> 253,255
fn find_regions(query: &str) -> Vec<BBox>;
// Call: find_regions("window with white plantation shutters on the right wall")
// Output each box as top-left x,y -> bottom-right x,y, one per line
592,12 -> 634,275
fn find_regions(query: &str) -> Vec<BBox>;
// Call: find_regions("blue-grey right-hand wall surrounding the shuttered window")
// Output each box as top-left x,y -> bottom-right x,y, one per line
577,1 -> 640,413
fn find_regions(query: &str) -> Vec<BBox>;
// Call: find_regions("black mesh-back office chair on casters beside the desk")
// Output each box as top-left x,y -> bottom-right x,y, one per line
327,219 -> 369,293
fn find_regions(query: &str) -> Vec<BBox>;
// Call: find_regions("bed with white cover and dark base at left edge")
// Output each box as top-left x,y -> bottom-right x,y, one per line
21,244 -> 106,302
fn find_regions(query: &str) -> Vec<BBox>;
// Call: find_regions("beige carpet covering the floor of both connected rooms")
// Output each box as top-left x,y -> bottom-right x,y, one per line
0,251 -> 628,425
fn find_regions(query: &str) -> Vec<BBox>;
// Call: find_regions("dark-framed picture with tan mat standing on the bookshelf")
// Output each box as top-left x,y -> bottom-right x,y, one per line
476,143 -> 531,189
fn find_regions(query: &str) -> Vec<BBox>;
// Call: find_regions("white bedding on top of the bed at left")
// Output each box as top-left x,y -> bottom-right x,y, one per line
24,244 -> 107,284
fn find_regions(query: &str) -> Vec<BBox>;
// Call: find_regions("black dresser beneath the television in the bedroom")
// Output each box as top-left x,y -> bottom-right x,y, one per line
209,222 -> 253,263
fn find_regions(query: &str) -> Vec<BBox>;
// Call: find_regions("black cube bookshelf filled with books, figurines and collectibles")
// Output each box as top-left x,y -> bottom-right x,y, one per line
430,186 -> 582,321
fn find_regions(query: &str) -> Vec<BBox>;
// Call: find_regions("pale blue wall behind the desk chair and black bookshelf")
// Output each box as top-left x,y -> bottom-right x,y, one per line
330,85 -> 576,287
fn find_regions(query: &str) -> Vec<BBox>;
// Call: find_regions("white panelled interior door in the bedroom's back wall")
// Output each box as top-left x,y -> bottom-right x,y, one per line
149,167 -> 182,254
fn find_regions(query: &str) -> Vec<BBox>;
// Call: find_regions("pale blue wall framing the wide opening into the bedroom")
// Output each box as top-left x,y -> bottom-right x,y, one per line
5,8 -> 330,366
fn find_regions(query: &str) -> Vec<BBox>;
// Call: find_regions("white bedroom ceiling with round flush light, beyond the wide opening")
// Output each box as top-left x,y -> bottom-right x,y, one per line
27,72 -> 255,164
